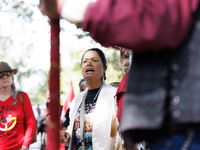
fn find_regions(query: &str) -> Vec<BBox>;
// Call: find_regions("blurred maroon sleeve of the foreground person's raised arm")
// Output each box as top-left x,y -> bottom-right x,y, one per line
81,0 -> 199,52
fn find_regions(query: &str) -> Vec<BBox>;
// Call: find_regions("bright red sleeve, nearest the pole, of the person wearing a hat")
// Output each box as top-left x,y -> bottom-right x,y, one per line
23,92 -> 36,147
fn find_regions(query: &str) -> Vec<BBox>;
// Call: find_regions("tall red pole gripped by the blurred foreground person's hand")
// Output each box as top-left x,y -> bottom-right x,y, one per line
46,19 -> 60,150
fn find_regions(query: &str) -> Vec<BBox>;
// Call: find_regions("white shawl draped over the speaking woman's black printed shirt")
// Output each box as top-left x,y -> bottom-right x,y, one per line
66,83 -> 117,150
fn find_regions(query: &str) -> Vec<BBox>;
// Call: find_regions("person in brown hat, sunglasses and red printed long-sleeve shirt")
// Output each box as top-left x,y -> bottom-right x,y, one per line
0,61 -> 36,150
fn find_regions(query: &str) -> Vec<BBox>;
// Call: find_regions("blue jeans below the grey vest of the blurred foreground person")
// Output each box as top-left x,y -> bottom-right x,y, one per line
149,131 -> 200,150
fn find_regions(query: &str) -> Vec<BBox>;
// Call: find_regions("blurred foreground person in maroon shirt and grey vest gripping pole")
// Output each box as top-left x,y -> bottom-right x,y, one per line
40,0 -> 200,150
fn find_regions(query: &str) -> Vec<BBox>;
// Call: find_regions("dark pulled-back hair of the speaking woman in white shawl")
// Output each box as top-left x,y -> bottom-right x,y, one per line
81,48 -> 107,80
